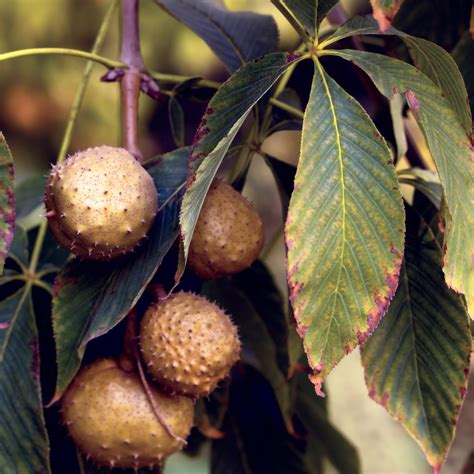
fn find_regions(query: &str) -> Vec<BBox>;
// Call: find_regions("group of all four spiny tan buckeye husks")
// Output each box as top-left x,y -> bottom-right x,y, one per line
45,146 -> 264,469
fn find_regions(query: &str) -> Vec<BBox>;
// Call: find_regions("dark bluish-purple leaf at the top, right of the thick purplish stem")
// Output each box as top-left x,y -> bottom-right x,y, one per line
155,0 -> 278,72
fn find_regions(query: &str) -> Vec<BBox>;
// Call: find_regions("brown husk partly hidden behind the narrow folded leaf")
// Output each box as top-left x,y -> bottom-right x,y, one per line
188,179 -> 265,280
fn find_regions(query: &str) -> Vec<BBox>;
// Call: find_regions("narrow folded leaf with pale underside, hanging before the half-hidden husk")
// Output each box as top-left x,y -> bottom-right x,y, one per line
178,53 -> 300,276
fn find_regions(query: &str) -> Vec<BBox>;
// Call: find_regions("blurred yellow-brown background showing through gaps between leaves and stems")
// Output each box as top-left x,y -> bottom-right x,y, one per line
0,0 -> 474,474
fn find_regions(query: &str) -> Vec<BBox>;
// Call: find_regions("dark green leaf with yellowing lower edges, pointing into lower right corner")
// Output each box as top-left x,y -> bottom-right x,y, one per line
362,207 -> 471,472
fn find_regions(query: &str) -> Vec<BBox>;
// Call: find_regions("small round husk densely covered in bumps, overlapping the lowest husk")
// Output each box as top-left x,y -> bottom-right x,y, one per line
140,292 -> 240,398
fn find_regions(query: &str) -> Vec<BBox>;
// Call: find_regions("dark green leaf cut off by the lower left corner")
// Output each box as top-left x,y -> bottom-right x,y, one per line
0,287 -> 50,473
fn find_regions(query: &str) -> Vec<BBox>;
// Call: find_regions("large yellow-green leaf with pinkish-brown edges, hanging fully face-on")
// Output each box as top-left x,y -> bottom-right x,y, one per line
286,57 -> 404,395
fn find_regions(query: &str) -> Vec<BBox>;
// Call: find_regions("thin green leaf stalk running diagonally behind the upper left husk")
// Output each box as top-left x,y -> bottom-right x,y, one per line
27,0 -> 119,274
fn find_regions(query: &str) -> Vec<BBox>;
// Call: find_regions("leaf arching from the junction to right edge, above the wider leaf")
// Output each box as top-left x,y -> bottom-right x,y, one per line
320,17 -> 472,134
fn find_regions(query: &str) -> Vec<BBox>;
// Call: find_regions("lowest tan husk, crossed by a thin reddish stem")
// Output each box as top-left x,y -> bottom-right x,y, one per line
62,359 -> 194,469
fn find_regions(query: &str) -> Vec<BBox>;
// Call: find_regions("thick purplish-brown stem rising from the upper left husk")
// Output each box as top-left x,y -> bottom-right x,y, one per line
120,0 -> 145,163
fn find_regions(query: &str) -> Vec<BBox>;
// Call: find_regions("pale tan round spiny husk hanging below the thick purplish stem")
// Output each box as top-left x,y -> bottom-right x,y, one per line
44,146 -> 158,260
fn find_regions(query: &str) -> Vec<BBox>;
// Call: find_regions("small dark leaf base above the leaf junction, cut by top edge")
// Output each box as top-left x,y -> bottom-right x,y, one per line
272,0 -> 337,41
